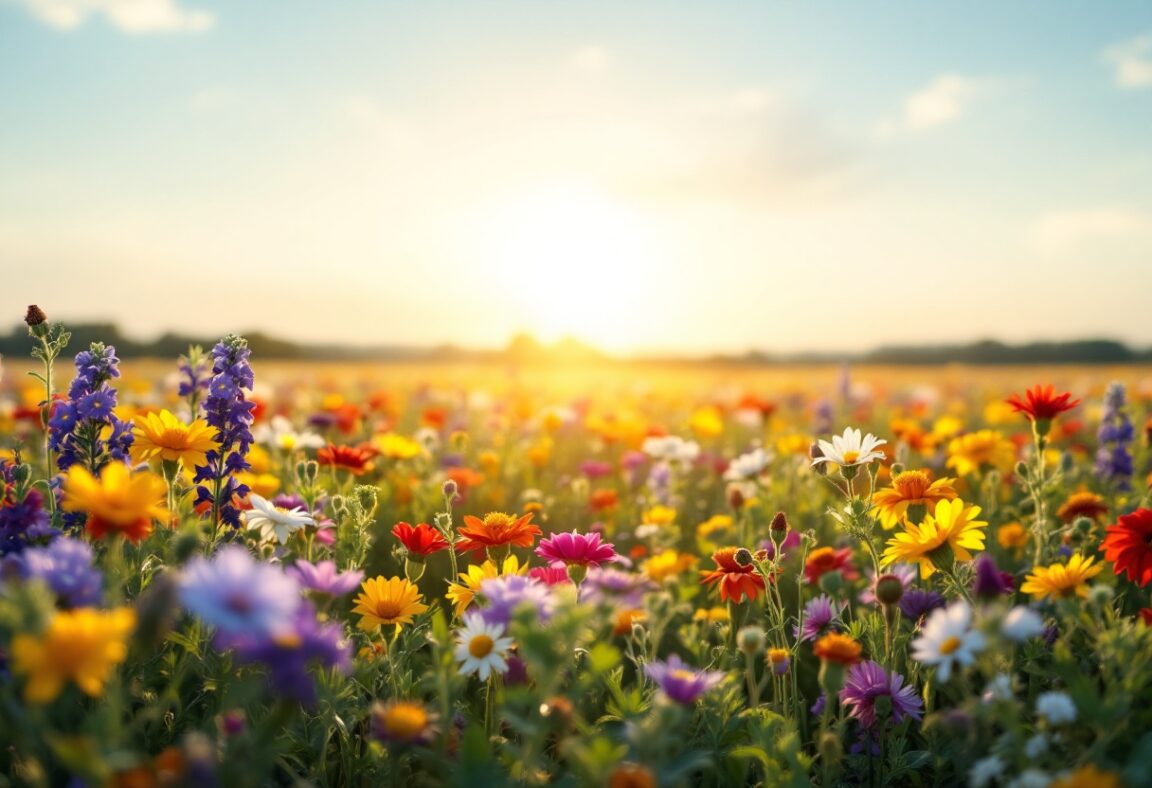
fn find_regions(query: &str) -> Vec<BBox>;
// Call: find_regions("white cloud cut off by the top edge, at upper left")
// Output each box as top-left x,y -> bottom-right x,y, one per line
23,0 -> 215,33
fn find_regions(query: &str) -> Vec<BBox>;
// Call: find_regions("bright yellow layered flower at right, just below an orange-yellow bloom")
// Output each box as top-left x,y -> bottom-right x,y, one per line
881,498 -> 987,579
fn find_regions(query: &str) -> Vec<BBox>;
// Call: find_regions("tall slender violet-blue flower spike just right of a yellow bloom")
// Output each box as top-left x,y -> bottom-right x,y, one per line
195,334 -> 256,528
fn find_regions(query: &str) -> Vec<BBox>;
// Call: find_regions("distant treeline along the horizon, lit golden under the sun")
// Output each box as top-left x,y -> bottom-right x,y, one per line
0,323 -> 1152,365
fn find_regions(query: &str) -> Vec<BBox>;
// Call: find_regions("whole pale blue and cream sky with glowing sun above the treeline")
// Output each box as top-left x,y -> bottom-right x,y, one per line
0,0 -> 1152,353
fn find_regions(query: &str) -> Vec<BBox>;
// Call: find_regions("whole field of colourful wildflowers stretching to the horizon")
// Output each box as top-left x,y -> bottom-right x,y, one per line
0,308 -> 1152,788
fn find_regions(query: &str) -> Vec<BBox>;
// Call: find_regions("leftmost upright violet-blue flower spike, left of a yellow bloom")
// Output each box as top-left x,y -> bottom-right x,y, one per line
48,342 -> 132,473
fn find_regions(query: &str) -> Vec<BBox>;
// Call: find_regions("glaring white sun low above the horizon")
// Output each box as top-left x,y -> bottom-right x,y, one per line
472,183 -> 668,351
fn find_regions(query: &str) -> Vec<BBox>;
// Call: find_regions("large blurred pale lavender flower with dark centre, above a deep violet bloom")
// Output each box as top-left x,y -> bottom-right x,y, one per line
180,545 -> 302,647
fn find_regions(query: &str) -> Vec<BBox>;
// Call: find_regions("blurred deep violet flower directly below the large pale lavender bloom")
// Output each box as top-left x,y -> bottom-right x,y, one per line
229,603 -> 351,705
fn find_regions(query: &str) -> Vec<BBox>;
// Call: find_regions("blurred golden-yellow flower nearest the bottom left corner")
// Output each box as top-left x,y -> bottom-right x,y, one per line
12,607 -> 136,703
